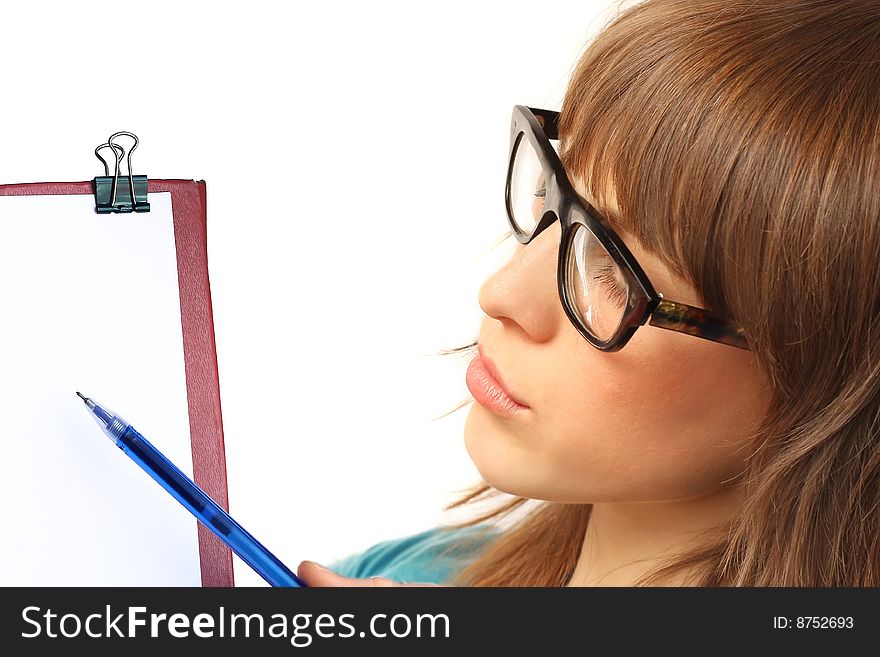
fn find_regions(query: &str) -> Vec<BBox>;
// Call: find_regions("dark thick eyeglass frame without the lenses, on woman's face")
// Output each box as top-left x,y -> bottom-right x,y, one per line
504,105 -> 749,351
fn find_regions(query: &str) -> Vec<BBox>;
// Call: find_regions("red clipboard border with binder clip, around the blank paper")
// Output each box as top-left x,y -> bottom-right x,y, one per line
0,133 -> 234,587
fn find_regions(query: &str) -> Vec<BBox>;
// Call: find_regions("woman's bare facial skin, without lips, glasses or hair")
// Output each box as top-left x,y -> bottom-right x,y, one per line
464,182 -> 770,503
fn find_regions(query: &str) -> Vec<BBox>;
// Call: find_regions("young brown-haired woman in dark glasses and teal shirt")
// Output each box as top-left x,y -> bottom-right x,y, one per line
299,0 -> 880,586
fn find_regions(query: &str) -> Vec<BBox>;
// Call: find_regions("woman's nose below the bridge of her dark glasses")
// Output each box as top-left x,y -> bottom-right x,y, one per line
478,221 -> 564,342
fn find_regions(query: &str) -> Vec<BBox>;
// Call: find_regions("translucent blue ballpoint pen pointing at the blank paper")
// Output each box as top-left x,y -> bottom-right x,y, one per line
76,392 -> 306,586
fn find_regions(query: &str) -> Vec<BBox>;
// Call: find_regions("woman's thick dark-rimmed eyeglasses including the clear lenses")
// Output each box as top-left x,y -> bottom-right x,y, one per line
504,105 -> 749,351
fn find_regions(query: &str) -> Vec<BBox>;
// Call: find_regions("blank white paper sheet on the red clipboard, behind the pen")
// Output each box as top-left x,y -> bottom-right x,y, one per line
0,192 -> 201,586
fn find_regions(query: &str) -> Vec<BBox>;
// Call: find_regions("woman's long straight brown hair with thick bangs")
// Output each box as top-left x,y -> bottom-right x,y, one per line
438,0 -> 880,586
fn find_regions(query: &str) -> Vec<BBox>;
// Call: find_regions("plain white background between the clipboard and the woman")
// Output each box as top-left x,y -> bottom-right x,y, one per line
0,0 -> 617,585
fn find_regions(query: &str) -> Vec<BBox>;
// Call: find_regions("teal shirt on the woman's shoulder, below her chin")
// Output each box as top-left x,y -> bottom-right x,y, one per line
328,524 -> 501,584
